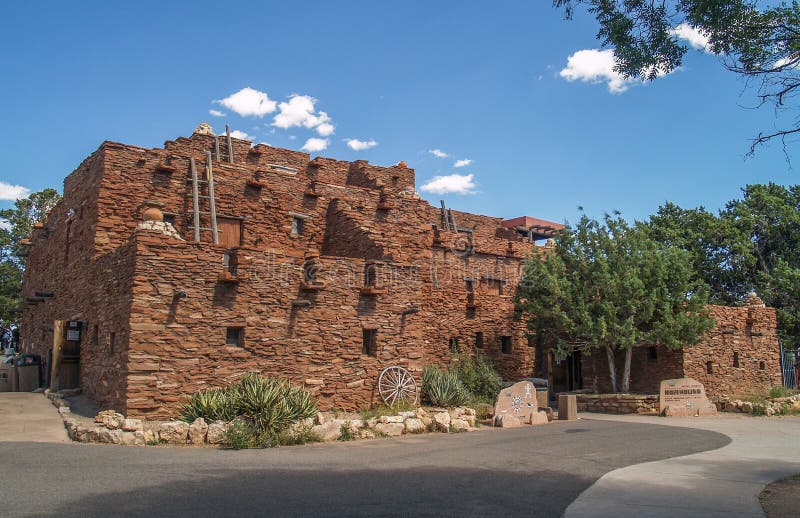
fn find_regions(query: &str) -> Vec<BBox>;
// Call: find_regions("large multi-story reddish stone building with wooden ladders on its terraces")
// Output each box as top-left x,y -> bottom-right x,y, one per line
17,125 -> 562,418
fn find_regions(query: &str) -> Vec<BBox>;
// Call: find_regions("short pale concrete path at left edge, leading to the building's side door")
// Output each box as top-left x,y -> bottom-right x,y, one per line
0,392 -> 70,442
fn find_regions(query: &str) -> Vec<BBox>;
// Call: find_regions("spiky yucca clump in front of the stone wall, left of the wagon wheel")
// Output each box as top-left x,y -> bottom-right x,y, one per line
181,373 -> 317,449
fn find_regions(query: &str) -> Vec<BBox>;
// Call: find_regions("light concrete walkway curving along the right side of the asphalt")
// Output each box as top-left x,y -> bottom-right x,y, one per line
564,413 -> 800,518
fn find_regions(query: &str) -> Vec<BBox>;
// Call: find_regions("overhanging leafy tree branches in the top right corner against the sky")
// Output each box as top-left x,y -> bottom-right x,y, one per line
553,0 -> 800,153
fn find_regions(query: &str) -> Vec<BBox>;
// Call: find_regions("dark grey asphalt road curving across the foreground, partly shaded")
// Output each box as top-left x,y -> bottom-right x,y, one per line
0,406 -> 729,517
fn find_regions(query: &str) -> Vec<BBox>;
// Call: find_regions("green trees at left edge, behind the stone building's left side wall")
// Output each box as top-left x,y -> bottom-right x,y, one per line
0,189 -> 61,325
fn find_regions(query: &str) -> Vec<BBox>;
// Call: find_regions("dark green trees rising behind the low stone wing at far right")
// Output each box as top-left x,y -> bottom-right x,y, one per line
641,183 -> 800,349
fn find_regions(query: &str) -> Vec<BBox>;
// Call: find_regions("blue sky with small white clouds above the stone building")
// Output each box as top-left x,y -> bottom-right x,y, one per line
0,0 -> 798,225
